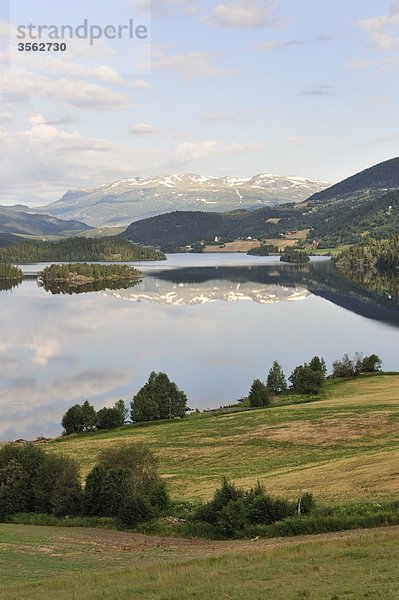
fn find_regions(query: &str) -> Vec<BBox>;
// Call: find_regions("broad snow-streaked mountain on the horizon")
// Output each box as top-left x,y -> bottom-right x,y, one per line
37,174 -> 329,227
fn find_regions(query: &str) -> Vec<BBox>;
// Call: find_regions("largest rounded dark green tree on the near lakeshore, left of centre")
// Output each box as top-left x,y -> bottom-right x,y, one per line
131,371 -> 188,422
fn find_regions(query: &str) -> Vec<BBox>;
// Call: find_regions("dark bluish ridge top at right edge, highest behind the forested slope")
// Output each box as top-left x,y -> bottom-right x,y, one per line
308,157 -> 399,204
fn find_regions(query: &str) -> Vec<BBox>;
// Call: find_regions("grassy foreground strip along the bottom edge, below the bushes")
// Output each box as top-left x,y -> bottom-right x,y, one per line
0,525 -> 399,600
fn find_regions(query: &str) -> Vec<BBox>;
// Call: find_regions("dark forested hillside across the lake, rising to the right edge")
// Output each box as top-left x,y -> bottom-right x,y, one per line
121,158 -> 399,249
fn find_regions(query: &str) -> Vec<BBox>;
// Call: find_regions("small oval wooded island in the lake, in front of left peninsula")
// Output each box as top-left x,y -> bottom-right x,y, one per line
39,263 -> 142,287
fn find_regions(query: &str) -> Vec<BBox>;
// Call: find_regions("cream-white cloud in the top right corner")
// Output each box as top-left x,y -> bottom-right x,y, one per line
360,0 -> 399,52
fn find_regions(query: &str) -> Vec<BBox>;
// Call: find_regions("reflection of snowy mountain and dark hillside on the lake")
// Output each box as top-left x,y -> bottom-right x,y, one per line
106,261 -> 399,326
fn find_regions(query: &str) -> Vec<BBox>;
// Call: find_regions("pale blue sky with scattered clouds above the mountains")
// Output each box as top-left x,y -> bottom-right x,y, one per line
0,0 -> 399,206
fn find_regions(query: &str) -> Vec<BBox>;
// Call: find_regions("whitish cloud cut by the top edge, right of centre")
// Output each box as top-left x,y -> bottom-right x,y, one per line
207,0 -> 278,29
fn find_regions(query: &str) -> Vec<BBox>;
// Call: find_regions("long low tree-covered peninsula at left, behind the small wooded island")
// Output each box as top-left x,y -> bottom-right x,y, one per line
0,237 -> 166,263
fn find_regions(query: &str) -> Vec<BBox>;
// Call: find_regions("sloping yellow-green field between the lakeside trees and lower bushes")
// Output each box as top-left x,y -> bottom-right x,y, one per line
44,375 -> 399,503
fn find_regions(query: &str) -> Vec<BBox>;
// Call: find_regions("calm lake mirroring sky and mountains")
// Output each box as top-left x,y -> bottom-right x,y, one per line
0,255 -> 399,440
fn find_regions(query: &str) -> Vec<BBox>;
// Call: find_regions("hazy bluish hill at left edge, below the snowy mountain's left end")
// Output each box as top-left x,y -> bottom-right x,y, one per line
0,206 -> 91,236
